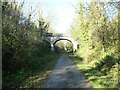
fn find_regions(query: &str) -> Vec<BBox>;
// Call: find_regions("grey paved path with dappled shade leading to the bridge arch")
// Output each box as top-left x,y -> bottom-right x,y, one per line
44,54 -> 92,88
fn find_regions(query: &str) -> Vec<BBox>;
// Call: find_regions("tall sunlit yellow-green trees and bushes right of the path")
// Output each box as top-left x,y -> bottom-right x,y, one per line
71,0 -> 120,87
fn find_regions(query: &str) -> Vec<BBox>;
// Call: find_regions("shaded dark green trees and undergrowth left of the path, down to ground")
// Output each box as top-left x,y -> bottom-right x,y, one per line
2,2 -> 57,88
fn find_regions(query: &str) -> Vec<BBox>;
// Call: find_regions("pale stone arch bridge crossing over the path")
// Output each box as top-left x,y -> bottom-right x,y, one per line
42,33 -> 78,52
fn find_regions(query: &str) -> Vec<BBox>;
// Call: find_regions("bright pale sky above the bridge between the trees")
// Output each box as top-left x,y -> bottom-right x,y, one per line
20,0 -> 77,33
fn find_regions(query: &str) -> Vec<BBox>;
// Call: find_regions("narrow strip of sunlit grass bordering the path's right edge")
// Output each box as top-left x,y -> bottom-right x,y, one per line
70,55 -> 119,88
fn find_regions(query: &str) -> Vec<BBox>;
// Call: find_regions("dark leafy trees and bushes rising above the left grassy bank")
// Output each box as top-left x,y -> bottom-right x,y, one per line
2,2 -> 50,73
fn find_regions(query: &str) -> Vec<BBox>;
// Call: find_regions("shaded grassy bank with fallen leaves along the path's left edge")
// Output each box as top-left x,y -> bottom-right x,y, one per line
2,52 -> 60,88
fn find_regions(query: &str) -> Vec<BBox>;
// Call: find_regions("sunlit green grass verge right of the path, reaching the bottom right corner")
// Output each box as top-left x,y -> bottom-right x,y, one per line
70,55 -> 119,89
